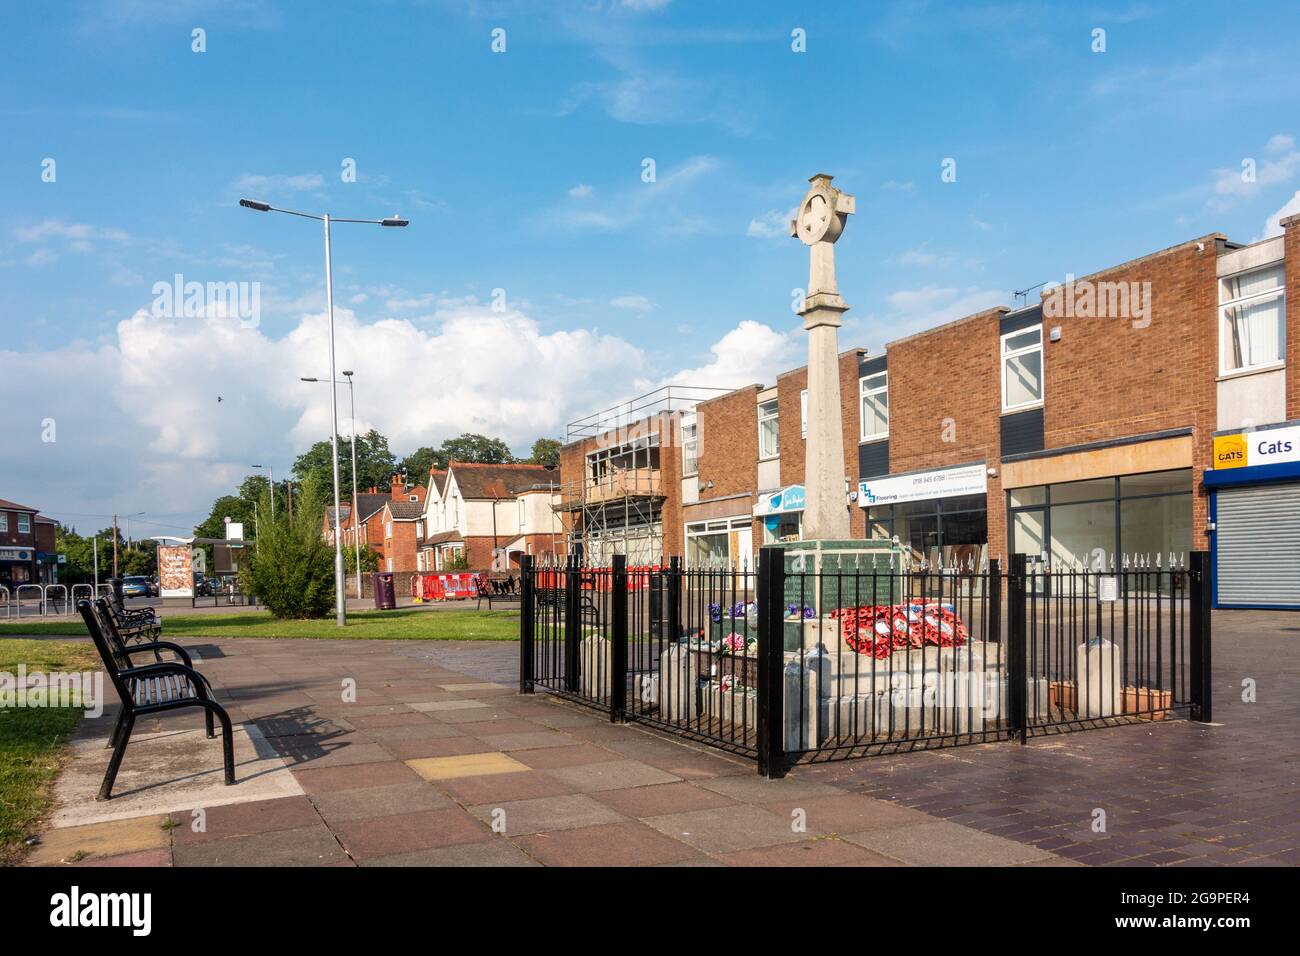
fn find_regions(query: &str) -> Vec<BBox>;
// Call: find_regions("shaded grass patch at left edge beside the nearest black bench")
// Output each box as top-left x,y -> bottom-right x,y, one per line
0,640 -> 99,866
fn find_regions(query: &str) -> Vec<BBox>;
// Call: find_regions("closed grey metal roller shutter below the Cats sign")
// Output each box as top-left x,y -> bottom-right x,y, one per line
1214,484 -> 1300,607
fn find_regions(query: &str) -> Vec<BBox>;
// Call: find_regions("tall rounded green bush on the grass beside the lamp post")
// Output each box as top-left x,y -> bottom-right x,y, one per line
241,483 -> 334,619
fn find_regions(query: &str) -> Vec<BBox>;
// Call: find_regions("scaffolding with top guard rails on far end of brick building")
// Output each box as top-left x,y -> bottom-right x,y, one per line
554,385 -> 728,566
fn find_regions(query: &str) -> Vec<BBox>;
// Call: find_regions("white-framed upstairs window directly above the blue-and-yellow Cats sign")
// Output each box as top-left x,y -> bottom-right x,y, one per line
1219,264 -> 1287,375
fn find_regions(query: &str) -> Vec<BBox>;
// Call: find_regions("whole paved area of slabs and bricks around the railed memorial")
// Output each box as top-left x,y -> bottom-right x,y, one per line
22,611 -> 1300,866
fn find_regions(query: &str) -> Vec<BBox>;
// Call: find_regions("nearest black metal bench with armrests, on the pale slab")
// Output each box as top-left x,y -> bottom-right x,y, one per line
77,598 -> 235,800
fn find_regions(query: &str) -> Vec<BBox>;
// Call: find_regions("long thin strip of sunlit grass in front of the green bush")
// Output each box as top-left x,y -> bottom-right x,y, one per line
0,610 -> 519,641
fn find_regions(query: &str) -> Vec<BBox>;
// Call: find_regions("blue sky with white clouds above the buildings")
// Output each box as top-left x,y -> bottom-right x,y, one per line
0,0 -> 1300,528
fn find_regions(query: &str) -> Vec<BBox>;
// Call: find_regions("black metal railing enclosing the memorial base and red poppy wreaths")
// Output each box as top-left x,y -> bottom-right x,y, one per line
520,548 -> 1210,775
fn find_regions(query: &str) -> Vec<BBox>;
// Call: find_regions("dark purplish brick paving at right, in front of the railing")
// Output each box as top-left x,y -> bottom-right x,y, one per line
809,611 -> 1300,866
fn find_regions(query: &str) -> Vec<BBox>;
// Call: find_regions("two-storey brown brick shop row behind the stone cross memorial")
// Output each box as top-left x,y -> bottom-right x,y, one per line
562,217 -> 1300,607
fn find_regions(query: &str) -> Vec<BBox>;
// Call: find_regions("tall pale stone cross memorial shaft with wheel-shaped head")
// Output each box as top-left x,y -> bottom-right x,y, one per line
790,173 -> 855,541
